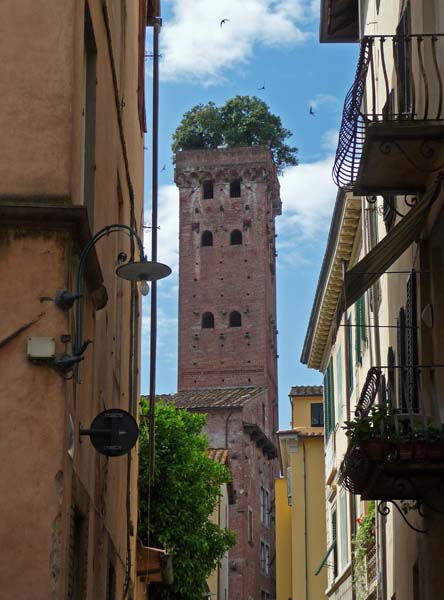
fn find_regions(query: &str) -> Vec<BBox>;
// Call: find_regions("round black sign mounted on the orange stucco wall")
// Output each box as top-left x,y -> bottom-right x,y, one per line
89,408 -> 139,456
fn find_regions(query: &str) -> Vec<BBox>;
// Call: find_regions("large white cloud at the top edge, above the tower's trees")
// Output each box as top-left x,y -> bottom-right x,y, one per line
161,0 -> 319,85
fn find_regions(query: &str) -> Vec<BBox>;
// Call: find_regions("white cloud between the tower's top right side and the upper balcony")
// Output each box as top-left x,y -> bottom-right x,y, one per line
277,156 -> 337,241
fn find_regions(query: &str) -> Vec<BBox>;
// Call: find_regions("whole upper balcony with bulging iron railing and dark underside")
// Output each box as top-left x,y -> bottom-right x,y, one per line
333,34 -> 444,195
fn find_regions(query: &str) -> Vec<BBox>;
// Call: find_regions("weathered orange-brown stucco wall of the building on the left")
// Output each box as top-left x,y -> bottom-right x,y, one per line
0,0 -> 143,600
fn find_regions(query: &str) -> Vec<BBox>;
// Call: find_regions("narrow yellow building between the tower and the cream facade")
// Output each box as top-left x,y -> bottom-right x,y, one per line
275,386 -> 327,600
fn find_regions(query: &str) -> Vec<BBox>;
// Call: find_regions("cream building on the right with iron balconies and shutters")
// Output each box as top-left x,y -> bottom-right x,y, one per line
302,0 -> 444,600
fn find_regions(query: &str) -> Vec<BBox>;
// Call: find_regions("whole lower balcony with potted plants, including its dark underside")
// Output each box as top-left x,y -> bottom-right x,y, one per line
339,366 -> 444,501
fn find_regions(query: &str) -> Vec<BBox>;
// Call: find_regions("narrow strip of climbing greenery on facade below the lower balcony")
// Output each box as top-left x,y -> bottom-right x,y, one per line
353,500 -> 375,600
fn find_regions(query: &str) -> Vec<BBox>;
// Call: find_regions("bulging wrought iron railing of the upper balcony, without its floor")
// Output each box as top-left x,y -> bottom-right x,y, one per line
333,34 -> 444,188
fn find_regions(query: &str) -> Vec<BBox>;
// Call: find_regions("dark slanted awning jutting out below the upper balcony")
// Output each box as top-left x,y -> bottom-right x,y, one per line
340,177 -> 443,313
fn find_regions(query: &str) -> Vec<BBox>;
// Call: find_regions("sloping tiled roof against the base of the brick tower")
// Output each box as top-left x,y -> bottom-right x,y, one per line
162,386 -> 267,409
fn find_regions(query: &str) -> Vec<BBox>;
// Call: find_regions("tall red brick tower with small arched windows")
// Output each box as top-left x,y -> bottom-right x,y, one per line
174,147 -> 281,600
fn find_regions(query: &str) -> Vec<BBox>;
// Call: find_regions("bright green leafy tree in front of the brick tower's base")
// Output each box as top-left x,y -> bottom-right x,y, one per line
138,402 -> 236,600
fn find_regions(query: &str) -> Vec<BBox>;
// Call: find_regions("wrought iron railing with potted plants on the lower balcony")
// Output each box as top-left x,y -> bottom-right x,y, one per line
339,365 -> 444,497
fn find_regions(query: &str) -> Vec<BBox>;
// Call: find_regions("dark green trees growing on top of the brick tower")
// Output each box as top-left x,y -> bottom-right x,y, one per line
172,96 -> 297,173
